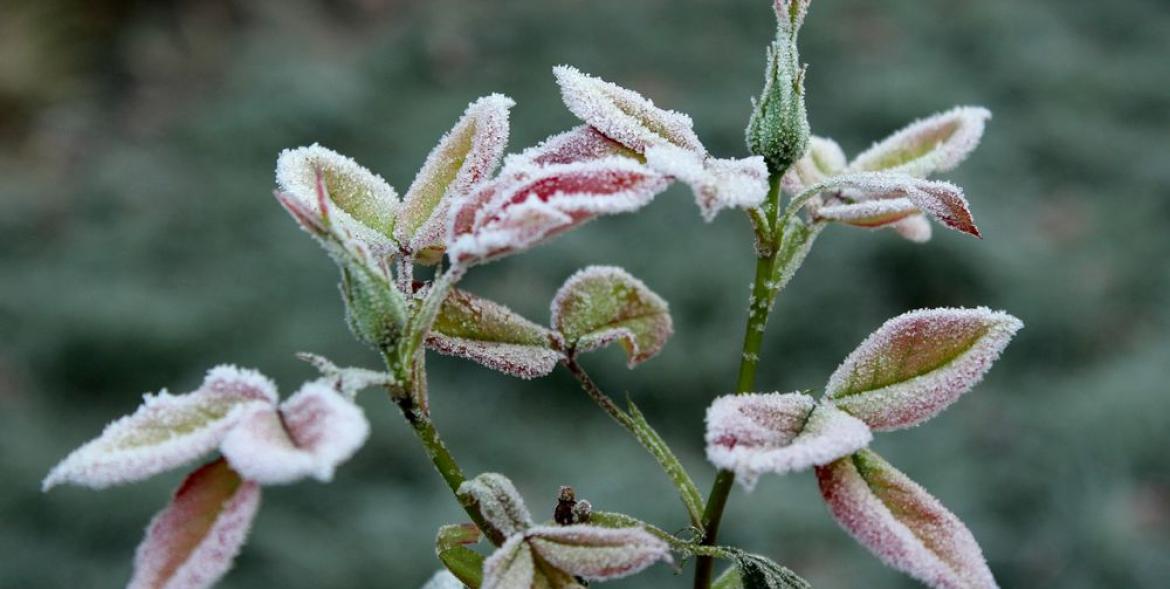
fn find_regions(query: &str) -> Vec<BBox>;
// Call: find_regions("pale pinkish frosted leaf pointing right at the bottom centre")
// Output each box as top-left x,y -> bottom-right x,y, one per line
527,525 -> 670,581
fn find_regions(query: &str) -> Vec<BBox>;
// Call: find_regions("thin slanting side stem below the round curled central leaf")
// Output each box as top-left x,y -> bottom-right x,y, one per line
564,354 -> 703,527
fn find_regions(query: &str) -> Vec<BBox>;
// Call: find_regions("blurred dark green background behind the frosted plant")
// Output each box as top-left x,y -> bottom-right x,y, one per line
0,0 -> 1170,589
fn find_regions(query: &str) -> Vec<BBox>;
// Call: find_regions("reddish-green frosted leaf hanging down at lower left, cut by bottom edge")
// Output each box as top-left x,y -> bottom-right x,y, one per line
129,459 -> 260,589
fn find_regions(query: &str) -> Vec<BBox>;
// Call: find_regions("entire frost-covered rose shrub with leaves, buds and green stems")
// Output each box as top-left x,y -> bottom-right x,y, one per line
44,0 -> 1020,589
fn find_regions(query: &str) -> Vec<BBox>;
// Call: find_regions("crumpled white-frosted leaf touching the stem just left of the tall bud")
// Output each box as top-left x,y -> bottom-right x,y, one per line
646,145 -> 769,221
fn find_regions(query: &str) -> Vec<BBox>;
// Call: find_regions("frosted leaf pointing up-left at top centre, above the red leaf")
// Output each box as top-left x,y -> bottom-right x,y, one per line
552,66 -> 707,156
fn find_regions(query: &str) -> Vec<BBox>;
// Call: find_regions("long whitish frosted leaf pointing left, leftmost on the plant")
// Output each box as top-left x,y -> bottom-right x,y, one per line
43,365 -> 276,489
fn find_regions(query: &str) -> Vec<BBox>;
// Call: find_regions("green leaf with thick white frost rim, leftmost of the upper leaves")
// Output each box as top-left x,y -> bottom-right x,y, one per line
276,144 -> 399,253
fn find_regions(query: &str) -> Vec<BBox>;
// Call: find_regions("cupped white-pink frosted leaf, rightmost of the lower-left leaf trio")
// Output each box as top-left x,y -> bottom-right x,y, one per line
220,379 -> 370,485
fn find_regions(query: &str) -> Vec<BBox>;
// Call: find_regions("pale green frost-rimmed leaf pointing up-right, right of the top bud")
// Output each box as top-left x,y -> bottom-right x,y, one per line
849,107 -> 991,178
